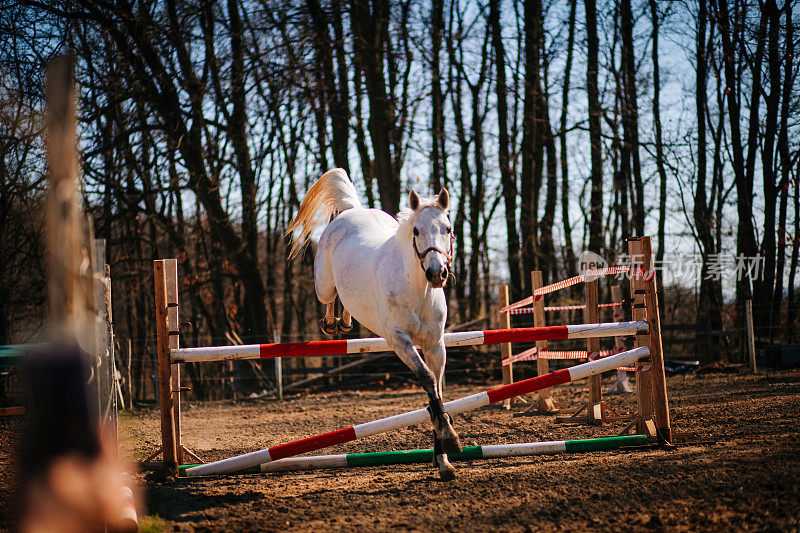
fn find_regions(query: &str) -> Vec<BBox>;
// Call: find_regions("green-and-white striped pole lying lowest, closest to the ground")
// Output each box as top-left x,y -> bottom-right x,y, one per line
179,435 -> 647,475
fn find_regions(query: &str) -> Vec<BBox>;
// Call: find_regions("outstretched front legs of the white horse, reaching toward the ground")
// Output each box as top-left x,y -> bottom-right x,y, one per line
392,331 -> 461,480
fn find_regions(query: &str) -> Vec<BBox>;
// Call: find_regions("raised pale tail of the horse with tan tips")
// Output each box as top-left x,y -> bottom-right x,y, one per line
286,168 -> 361,259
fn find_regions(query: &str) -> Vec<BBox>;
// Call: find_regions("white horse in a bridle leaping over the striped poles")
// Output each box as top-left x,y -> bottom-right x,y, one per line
287,168 -> 461,480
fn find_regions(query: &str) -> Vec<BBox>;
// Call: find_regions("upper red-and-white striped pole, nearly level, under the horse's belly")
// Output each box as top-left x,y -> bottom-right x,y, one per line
170,321 -> 648,363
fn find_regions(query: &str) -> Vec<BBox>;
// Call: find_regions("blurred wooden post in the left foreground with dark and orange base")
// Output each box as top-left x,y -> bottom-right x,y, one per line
20,58 -> 137,533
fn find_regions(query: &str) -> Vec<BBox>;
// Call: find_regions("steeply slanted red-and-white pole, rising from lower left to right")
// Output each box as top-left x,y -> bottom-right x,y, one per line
186,348 -> 650,476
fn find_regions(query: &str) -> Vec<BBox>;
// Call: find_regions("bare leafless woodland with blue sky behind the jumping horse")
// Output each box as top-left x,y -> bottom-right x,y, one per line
0,0 -> 800,399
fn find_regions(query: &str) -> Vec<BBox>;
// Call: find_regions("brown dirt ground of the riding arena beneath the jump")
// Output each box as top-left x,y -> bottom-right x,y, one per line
0,370 -> 800,531
